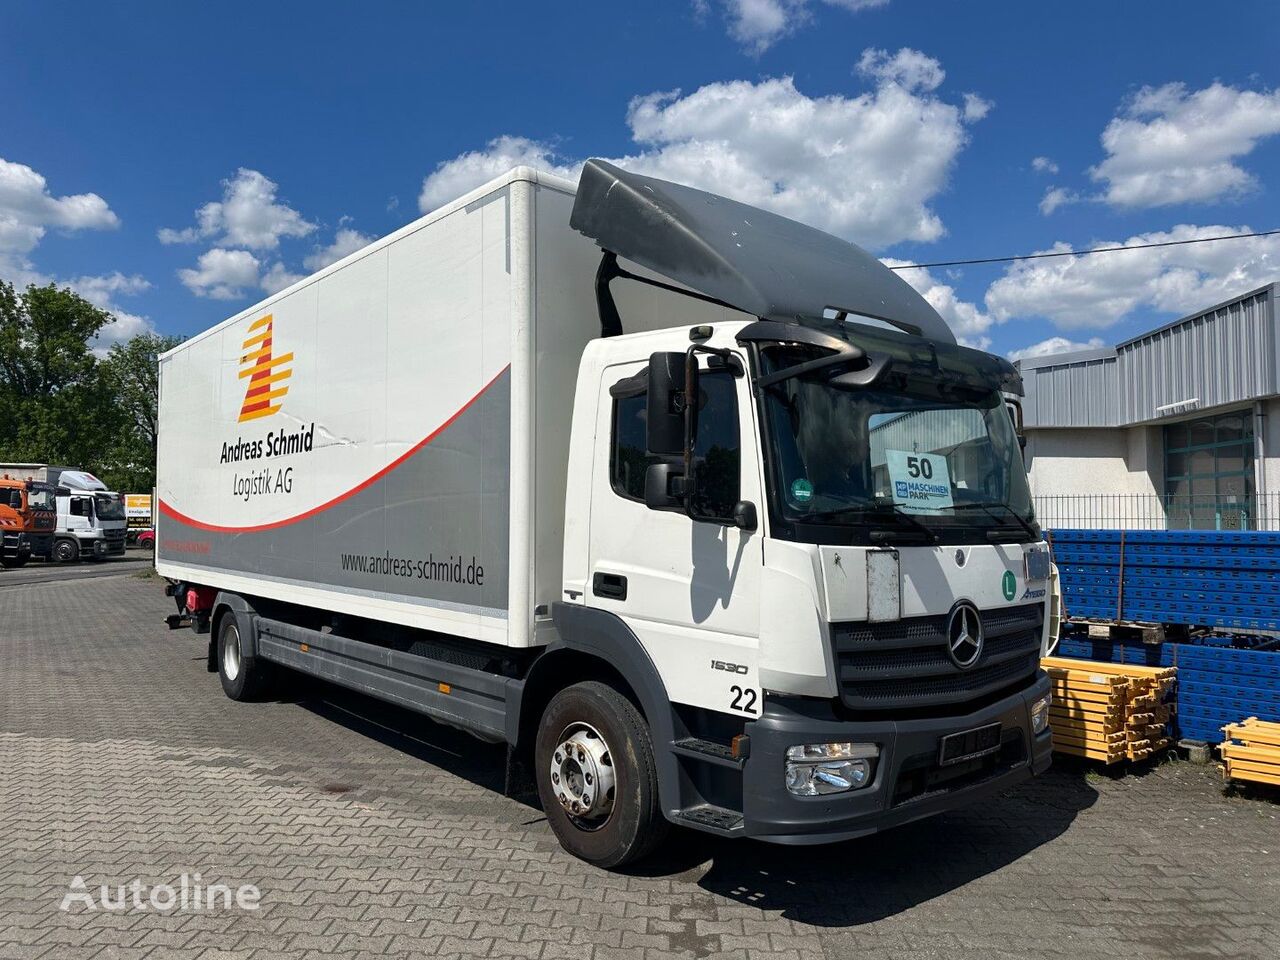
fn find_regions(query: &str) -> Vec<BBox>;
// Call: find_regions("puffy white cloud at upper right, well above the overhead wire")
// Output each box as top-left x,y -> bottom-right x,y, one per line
1089,82 -> 1280,207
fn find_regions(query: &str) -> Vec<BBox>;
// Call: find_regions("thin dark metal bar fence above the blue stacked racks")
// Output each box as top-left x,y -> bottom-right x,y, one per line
1033,492 -> 1280,530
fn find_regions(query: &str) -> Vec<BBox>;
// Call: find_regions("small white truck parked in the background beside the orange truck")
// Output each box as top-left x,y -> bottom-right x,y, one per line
0,463 -> 127,563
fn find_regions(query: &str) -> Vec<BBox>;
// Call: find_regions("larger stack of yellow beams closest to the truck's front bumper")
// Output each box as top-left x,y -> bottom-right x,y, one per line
1041,657 -> 1178,763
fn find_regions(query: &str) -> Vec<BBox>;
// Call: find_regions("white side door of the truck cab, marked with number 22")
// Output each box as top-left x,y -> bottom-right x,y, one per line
586,360 -> 763,717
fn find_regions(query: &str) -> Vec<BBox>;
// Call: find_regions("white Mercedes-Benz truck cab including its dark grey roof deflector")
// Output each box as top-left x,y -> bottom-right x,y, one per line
538,161 -> 1051,844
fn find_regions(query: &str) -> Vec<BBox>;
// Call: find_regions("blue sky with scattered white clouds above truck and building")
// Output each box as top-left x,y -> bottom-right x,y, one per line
0,0 -> 1280,353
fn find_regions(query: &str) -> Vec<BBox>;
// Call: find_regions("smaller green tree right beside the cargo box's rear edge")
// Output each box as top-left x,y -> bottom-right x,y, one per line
102,333 -> 182,493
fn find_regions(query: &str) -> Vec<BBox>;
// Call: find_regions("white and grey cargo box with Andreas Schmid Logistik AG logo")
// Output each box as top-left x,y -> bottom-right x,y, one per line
156,169 -> 614,646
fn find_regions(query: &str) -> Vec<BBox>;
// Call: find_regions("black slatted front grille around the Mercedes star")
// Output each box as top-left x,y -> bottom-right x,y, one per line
832,603 -> 1044,710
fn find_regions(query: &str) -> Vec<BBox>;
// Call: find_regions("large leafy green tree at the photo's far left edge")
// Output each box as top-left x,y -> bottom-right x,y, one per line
0,280 -> 123,470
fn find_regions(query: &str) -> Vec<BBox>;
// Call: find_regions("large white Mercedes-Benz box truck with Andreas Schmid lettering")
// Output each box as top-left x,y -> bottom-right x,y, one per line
156,161 -> 1051,867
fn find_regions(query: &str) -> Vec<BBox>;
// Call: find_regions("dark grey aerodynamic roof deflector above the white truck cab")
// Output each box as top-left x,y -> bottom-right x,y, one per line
570,160 -> 955,343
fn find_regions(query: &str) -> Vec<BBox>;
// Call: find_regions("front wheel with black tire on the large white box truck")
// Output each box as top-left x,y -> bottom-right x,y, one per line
534,680 -> 668,869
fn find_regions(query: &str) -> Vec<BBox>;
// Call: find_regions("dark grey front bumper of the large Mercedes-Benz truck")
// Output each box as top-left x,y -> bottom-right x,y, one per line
742,671 -> 1052,844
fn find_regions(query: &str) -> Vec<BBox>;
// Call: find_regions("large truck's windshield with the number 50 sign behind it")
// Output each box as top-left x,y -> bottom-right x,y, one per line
760,346 -> 1034,543
